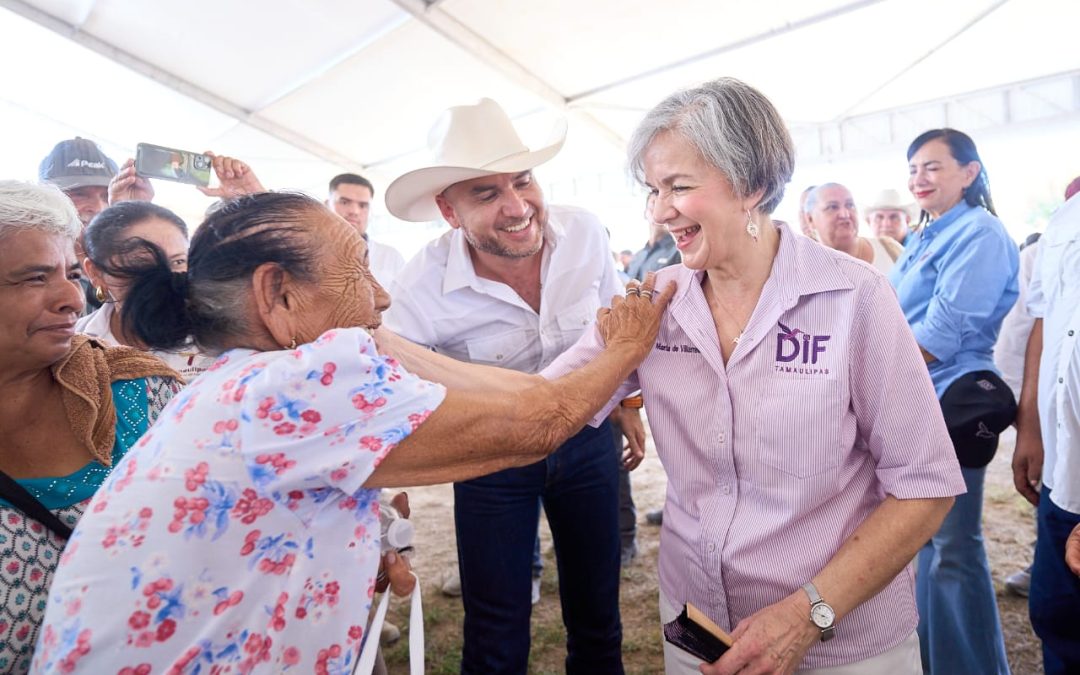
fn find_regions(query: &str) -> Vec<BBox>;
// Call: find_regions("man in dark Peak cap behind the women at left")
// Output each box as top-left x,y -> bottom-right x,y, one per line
38,136 -> 118,312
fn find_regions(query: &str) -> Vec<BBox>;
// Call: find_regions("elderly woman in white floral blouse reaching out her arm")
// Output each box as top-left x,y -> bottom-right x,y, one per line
33,193 -> 671,673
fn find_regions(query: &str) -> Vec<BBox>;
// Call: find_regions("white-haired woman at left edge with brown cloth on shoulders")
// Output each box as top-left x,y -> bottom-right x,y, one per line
0,180 -> 179,673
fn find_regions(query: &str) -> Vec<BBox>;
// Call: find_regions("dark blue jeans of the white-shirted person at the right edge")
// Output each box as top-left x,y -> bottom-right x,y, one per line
1028,487 -> 1080,675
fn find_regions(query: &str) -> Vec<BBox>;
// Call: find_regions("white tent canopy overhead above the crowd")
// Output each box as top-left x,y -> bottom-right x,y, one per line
0,0 -> 1080,248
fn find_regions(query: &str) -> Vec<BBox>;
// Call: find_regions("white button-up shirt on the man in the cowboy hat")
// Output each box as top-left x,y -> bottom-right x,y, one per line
384,206 -> 624,373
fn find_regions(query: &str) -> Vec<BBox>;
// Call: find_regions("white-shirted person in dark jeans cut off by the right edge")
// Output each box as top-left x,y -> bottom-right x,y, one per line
1013,185 -> 1080,675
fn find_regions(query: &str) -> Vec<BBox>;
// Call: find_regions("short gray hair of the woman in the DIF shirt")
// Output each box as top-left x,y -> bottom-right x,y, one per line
626,78 -> 795,214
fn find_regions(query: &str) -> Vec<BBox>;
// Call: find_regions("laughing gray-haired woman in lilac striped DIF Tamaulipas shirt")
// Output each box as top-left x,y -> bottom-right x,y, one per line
544,78 -> 963,675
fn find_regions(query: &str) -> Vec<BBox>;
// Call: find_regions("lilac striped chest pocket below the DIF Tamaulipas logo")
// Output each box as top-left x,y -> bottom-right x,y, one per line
752,377 -> 848,480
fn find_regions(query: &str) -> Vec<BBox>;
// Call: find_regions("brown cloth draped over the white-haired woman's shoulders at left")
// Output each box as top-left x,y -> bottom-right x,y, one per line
51,335 -> 184,467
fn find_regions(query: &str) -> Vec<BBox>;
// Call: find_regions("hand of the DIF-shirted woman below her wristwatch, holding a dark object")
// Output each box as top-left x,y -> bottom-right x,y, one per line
700,591 -> 821,675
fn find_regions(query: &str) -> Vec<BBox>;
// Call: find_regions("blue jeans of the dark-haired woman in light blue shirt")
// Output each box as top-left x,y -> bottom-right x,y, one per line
915,467 -> 1009,675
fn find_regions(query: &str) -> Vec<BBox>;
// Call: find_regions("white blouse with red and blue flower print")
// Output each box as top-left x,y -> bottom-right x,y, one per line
31,328 -> 445,675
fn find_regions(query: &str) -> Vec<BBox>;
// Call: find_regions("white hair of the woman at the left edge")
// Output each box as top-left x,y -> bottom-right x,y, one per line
0,180 -> 82,240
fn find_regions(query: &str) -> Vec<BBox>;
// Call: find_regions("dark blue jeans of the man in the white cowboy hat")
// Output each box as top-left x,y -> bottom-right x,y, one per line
454,422 -> 623,675
